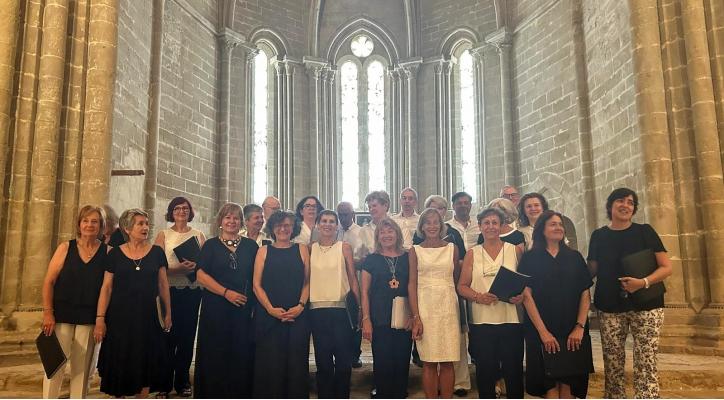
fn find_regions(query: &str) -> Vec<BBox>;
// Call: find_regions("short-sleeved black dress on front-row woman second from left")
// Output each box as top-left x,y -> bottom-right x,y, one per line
98,246 -> 168,397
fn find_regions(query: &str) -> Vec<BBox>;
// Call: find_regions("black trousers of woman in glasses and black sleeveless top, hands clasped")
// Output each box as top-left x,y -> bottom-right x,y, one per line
253,314 -> 309,399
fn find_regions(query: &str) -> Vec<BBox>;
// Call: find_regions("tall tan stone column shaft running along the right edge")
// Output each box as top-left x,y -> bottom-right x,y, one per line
681,0 -> 724,307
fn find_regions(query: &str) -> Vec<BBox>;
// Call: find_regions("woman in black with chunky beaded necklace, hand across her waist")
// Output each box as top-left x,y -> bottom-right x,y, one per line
194,203 -> 258,398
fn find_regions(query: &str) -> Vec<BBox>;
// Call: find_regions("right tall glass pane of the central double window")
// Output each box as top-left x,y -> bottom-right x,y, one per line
367,61 -> 387,191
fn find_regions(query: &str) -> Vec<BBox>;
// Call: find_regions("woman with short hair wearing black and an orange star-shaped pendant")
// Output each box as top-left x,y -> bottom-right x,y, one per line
362,218 -> 412,399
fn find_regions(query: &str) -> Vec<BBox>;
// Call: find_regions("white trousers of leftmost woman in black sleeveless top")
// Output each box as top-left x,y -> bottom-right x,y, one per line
43,324 -> 95,399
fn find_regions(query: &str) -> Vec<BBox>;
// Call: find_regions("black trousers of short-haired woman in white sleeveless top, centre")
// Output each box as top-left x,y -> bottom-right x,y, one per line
309,308 -> 352,399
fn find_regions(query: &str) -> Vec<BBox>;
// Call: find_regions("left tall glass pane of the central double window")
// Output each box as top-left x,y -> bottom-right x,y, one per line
340,61 -> 359,208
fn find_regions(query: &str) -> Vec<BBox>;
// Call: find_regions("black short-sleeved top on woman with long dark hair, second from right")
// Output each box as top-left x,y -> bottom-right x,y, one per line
518,247 -> 593,337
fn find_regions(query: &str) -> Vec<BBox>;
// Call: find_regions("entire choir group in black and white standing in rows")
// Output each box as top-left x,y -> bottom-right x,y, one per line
42,186 -> 671,398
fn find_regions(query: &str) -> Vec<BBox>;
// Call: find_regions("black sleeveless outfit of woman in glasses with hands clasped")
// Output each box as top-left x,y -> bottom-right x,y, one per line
254,244 -> 309,398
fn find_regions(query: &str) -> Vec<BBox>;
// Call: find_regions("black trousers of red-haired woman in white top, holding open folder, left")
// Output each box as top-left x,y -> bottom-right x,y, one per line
162,287 -> 202,392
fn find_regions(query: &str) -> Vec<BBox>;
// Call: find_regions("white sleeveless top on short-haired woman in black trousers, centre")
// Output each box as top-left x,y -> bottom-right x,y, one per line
309,241 -> 349,308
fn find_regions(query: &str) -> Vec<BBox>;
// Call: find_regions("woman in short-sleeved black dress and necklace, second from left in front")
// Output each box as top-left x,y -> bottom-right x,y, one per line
93,208 -> 171,397
